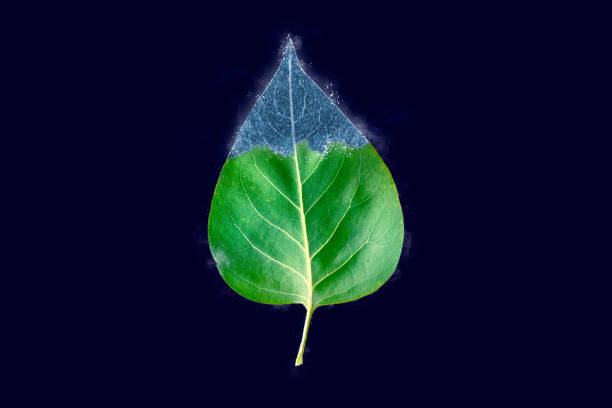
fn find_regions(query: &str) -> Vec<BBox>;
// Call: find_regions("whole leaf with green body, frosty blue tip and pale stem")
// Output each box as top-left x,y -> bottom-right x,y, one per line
208,40 -> 404,365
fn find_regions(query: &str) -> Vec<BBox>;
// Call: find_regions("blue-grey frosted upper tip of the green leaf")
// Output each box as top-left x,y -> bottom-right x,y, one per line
230,40 -> 368,157
